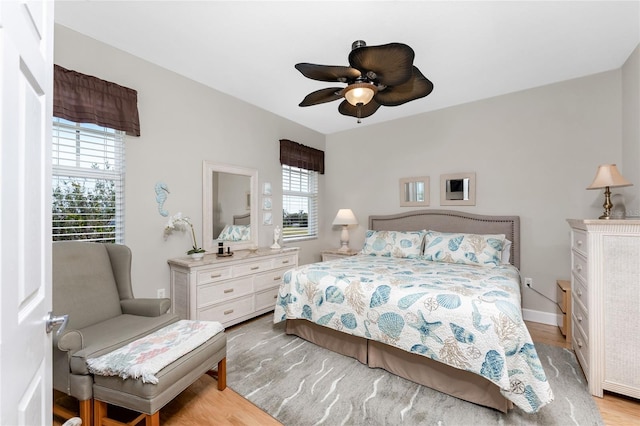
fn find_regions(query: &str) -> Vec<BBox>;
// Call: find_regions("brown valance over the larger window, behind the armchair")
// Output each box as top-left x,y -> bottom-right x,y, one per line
53,65 -> 140,136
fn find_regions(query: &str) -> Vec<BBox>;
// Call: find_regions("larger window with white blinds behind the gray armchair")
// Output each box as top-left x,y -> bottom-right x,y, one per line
52,117 -> 125,244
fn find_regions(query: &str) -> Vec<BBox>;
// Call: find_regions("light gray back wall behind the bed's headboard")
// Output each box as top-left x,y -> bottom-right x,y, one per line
323,70 -> 621,313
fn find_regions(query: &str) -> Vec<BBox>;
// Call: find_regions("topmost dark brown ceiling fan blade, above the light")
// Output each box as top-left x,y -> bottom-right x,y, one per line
349,43 -> 415,86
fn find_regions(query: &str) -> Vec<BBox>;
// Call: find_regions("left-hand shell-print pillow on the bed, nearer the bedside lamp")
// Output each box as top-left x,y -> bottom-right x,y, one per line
360,230 -> 427,258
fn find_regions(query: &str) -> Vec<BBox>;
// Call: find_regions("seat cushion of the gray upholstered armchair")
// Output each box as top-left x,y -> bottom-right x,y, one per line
69,314 -> 179,374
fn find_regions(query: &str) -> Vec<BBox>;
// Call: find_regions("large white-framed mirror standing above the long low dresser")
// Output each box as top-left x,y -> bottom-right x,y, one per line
202,161 -> 258,253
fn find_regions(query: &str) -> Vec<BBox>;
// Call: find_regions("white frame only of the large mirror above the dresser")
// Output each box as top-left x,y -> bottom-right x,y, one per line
202,160 -> 259,253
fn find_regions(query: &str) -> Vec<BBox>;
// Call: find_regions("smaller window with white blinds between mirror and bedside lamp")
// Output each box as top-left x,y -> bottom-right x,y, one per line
282,164 -> 318,241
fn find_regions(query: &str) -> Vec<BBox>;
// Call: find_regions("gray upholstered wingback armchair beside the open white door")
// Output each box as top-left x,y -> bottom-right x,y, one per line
52,241 -> 179,425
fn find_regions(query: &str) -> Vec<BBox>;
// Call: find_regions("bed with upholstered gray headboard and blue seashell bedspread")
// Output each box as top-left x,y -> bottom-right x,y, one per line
274,210 -> 553,412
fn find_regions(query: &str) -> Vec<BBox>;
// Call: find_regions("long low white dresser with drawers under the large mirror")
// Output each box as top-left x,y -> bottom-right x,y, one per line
168,247 -> 298,327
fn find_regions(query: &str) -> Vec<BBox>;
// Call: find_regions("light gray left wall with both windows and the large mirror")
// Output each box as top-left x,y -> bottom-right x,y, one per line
54,25 -> 325,297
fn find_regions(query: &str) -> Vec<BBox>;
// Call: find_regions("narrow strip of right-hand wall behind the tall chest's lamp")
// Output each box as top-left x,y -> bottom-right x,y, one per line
624,45 -> 640,217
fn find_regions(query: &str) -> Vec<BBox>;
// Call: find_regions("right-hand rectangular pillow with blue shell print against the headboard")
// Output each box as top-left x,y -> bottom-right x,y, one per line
424,231 -> 505,267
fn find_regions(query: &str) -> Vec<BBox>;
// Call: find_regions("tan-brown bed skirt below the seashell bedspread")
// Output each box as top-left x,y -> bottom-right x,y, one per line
286,319 -> 513,413
